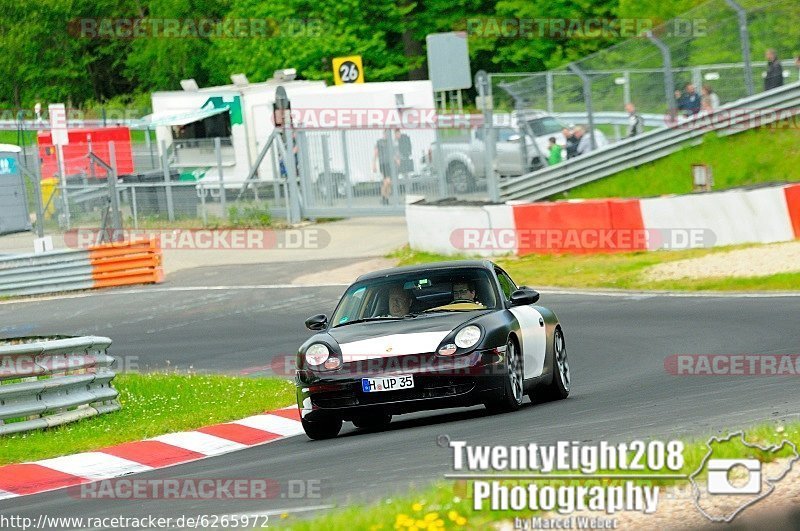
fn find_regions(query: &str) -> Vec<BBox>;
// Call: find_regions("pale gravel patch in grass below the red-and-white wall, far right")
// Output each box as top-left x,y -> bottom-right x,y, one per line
645,241 -> 800,281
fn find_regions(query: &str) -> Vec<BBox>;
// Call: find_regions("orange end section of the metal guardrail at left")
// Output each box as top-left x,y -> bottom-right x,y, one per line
89,239 -> 164,288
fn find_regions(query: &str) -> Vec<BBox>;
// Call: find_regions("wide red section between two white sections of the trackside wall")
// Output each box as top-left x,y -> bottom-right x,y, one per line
513,199 -> 647,256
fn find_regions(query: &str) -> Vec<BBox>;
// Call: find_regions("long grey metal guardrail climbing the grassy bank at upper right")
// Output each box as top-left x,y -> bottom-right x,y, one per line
500,83 -> 800,201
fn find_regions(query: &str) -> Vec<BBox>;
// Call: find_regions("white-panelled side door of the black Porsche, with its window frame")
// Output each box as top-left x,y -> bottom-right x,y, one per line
495,267 -> 547,380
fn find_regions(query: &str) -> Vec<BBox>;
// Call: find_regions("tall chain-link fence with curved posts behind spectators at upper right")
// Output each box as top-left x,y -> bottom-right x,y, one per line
491,0 -> 800,113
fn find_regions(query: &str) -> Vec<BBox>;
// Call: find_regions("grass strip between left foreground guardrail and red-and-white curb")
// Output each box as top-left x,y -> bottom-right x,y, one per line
0,373 -> 294,464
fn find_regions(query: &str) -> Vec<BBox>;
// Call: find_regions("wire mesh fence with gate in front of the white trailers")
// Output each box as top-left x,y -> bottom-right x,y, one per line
28,125 -> 506,234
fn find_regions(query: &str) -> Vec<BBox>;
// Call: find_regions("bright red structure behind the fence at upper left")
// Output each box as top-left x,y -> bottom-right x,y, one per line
38,127 -> 133,179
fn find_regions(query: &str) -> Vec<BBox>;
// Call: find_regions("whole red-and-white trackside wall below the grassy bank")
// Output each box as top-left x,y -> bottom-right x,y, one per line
406,184 -> 800,256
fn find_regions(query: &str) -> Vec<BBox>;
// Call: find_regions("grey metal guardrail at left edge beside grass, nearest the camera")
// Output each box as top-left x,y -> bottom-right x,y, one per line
0,336 -> 121,435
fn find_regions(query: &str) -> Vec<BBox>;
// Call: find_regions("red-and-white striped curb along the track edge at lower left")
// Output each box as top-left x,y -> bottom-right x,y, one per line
0,406 -> 303,500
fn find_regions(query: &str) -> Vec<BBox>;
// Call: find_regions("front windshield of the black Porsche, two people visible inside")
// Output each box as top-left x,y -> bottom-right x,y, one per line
331,268 -> 498,327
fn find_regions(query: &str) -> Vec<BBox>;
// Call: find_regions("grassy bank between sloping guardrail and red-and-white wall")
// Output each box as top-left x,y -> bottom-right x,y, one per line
551,127 -> 800,199
